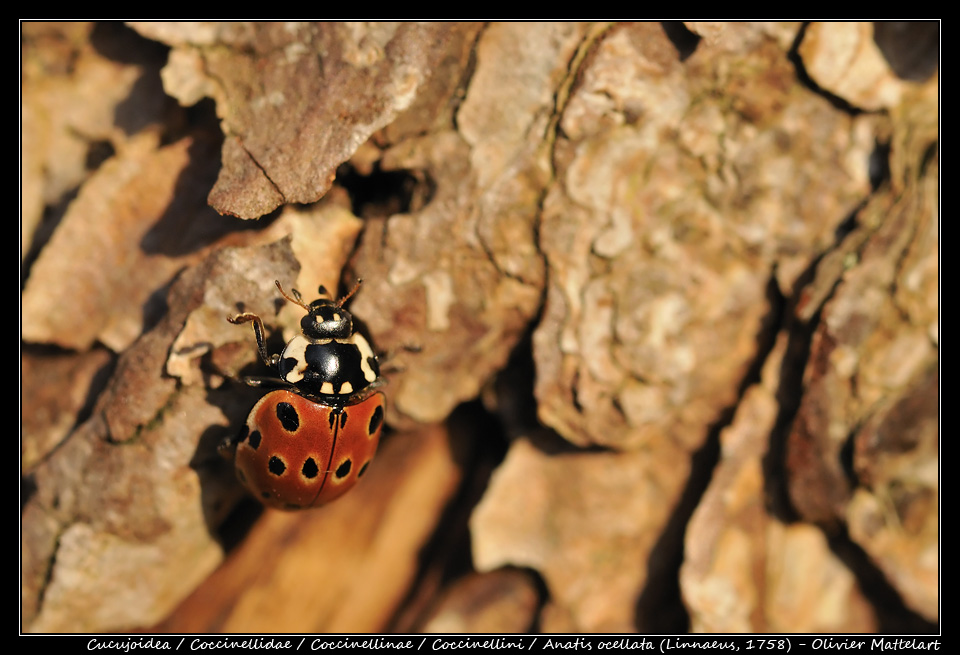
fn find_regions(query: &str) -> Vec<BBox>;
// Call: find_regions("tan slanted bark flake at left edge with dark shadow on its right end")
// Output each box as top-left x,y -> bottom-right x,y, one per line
23,133 -> 236,352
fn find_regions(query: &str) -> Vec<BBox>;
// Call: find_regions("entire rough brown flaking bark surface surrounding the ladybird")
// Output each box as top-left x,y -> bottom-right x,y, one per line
21,23 -> 940,633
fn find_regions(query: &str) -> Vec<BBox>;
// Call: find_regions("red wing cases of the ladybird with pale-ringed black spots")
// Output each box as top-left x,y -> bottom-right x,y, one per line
235,389 -> 385,509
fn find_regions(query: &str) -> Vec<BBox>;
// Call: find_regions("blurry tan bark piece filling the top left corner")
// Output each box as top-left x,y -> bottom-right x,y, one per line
21,22 -> 182,254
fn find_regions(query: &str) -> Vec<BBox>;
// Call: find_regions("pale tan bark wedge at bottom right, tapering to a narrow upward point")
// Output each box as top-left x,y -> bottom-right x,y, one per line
680,332 -> 878,633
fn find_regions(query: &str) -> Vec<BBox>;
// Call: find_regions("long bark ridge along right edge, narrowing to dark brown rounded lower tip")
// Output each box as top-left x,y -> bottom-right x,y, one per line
787,80 -> 939,525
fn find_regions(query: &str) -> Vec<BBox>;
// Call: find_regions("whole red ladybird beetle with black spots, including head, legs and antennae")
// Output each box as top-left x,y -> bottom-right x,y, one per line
225,282 -> 385,509
